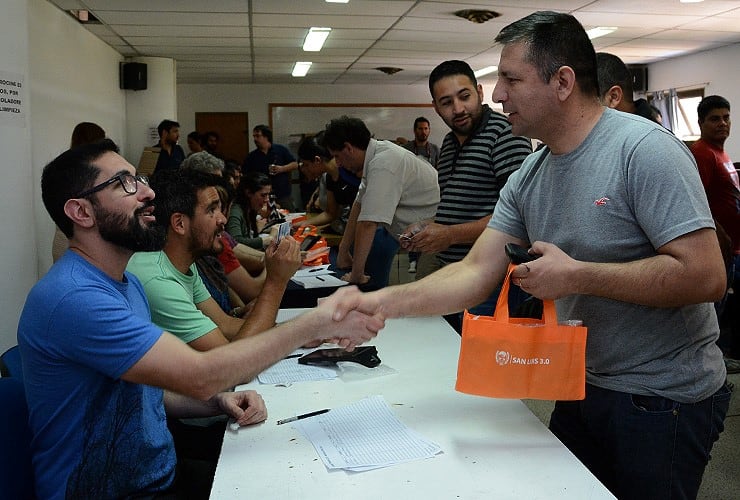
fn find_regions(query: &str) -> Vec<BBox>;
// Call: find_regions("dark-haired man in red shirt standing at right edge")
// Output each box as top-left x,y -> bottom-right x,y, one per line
691,95 -> 740,373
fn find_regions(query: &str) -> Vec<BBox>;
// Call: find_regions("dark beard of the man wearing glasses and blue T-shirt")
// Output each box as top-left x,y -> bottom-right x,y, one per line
95,201 -> 167,252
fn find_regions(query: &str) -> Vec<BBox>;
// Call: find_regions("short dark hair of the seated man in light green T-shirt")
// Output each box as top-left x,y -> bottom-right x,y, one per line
149,168 -> 223,228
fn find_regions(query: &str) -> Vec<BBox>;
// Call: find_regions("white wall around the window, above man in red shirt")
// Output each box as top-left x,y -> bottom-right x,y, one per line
648,44 -> 740,161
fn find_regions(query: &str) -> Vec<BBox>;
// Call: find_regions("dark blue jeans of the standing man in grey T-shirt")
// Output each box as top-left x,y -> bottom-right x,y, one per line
550,384 -> 731,500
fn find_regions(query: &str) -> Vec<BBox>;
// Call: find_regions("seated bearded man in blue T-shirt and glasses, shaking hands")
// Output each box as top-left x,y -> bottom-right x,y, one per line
18,140 -> 383,499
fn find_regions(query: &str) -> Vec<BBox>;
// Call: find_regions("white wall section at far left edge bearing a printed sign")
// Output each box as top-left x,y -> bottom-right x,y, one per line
0,0 -> 36,352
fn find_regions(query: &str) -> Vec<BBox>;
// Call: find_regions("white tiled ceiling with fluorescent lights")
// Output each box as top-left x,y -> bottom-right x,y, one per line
44,0 -> 740,84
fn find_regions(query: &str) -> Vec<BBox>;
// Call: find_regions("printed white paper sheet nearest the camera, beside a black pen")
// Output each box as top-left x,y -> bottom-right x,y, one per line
293,396 -> 442,472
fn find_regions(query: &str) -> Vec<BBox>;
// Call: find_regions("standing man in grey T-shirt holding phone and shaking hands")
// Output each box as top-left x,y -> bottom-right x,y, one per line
334,12 -> 730,498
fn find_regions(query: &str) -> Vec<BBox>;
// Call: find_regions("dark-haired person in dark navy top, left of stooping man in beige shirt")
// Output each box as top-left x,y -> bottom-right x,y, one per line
295,132 -> 360,234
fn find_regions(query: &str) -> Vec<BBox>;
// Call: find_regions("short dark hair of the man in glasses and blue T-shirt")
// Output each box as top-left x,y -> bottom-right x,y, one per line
41,139 -> 118,238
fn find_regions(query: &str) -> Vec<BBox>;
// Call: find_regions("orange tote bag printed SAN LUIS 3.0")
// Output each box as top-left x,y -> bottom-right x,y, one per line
455,265 -> 586,400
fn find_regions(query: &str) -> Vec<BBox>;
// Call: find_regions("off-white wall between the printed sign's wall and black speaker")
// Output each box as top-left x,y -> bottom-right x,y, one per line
28,0 -> 127,278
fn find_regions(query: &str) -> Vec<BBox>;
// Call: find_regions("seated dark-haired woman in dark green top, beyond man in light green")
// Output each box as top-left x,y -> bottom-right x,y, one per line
226,172 -> 272,250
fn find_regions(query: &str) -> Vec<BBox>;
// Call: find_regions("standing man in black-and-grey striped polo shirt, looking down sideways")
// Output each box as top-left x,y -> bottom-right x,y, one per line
408,60 -> 532,331
